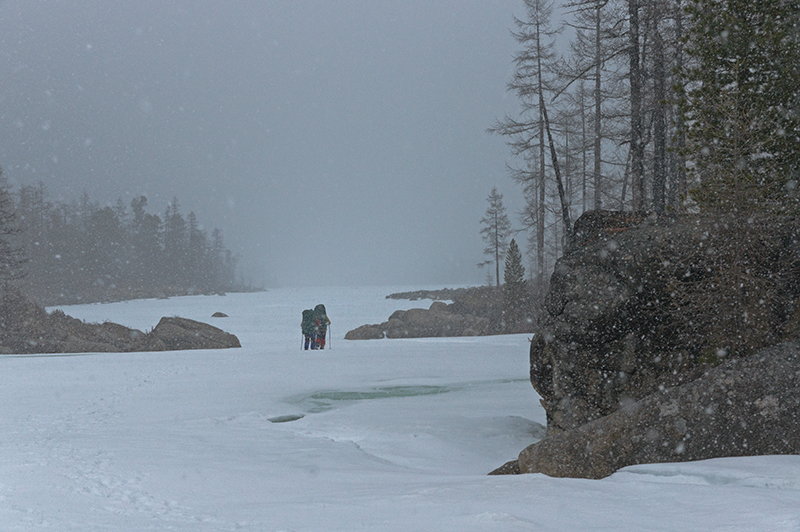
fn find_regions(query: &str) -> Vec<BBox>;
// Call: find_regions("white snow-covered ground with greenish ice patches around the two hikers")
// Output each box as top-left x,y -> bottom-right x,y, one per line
0,287 -> 800,532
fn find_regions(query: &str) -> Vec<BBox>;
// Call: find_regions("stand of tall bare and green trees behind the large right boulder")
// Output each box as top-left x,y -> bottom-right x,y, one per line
490,0 -> 800,296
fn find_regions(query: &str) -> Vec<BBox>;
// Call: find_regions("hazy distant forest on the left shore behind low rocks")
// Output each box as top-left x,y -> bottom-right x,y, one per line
13,184 -> 244,305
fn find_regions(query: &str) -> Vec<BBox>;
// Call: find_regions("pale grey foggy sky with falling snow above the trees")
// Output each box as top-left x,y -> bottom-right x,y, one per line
0,0 -> 523,286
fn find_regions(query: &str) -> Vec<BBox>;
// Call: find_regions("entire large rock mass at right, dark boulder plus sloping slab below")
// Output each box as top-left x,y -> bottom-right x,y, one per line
495,212 -> 800,478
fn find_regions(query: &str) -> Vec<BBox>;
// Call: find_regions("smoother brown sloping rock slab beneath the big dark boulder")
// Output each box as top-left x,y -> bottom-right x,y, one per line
516,342 -> 800,478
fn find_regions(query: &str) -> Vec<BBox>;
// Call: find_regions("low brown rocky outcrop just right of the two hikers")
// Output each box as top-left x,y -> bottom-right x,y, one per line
345,301 -> 489,340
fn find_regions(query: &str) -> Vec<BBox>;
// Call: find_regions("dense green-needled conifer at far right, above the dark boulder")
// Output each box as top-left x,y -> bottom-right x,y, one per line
681,0 -> 800,211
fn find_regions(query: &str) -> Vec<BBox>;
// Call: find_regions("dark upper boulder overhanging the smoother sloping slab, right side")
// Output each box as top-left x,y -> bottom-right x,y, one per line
530,212 -> 800,435
